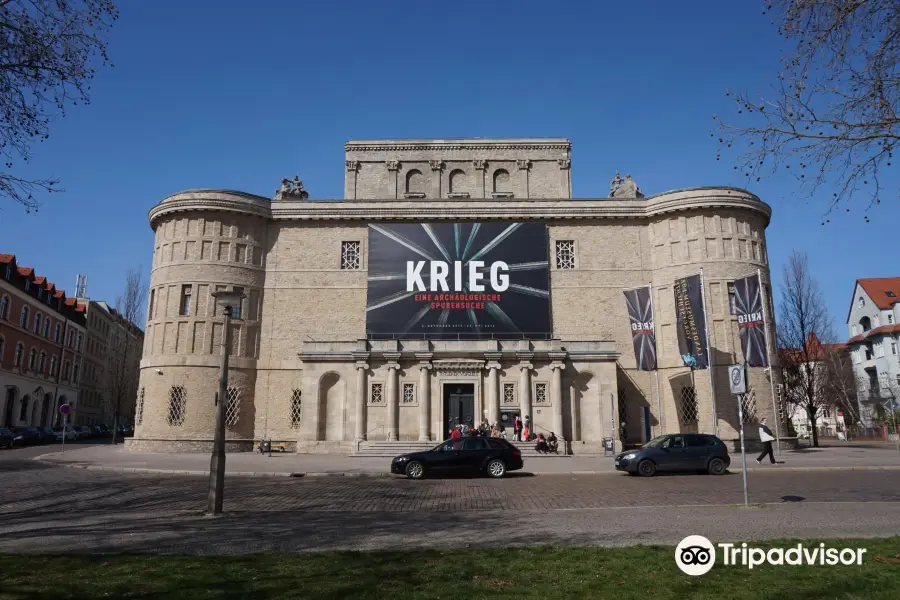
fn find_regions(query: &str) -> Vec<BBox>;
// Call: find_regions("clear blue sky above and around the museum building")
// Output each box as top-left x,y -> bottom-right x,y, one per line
0,0 -> 900,335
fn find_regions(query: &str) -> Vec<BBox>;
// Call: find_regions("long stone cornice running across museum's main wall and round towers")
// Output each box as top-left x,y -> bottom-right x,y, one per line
150,188 -> 772,227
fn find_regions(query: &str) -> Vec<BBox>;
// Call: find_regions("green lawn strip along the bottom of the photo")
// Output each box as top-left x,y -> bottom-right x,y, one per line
0,537 -> 900,600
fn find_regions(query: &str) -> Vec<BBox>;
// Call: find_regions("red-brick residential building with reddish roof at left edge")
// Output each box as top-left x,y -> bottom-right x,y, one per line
0,254 -> 86,427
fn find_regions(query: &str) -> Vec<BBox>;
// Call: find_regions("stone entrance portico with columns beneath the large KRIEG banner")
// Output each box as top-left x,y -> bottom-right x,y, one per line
297,339 -> 618,451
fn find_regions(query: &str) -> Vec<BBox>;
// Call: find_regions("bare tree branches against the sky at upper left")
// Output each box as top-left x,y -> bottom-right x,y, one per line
0,0 -> 119,211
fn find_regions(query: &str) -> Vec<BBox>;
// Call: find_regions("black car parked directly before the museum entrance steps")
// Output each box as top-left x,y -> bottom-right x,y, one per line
391,437 -> 523,479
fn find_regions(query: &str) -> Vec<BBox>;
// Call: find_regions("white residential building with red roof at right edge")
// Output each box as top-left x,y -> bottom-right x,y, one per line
847,277 -> 900,427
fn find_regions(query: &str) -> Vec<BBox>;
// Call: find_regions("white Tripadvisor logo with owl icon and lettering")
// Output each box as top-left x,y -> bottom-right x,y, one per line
675,535 -> 866,577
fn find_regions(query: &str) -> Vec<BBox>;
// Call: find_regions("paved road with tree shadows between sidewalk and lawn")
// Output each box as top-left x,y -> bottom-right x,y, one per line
0,449 -> 900,553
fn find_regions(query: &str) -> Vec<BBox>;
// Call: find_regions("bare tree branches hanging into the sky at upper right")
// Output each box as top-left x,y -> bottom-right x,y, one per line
710,0 -> 900,221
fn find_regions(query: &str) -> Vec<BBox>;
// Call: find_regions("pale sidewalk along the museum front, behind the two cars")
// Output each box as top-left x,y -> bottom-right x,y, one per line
35,445 -> 900,477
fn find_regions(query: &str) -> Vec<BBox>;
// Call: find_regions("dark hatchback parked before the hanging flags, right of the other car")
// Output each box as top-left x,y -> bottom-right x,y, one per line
616,433 -> 731,477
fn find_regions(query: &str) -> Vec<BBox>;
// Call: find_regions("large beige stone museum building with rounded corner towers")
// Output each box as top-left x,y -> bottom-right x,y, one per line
129,139 -> 776,454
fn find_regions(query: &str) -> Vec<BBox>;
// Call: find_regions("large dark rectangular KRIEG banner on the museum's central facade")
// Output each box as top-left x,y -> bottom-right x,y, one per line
366,222 -> 551,339
